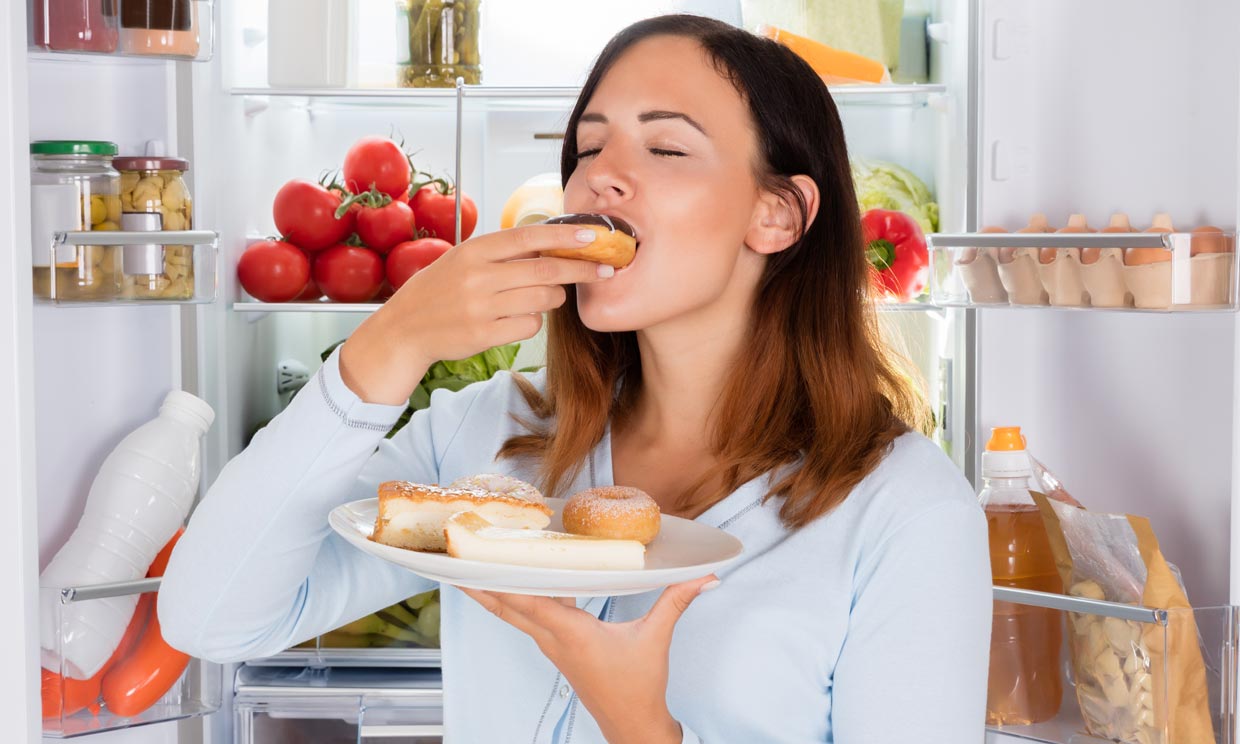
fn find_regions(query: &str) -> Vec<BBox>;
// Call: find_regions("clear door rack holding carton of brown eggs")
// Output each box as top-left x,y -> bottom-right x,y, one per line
926,231 -> 1238,312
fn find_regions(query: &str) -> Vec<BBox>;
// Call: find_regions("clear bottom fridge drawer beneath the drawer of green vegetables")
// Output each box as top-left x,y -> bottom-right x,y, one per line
233,666 -> 444,744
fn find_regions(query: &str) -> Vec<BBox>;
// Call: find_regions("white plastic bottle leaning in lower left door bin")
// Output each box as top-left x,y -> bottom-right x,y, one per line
40,391 -> 215,680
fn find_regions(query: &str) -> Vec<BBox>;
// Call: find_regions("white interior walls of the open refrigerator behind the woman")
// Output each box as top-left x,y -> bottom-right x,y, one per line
16,0 -> 1240,744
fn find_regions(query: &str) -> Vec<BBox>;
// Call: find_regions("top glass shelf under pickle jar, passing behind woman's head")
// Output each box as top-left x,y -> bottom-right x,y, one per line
231,84 -> 946,112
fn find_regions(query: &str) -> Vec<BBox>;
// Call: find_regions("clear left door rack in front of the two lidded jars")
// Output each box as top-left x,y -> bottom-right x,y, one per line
41,229 -> 219,308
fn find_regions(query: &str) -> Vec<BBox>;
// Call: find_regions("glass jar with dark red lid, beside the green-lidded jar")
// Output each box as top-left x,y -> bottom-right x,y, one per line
113,156 -> 193,300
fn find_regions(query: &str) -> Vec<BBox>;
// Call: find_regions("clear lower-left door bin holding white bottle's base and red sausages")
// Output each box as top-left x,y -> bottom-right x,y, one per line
40,578 -> 223,739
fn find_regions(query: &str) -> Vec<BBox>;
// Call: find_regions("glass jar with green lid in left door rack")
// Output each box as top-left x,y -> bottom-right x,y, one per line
30,140 -> 120,301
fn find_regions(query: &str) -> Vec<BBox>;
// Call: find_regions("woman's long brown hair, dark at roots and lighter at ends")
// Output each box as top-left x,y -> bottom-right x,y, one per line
500,15 -> 930,528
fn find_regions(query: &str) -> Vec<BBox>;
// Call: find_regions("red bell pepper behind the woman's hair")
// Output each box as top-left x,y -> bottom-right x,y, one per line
861,210 -> 930,303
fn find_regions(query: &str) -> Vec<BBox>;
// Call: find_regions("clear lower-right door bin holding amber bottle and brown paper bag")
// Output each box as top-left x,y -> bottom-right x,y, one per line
987,587 -> 1240,744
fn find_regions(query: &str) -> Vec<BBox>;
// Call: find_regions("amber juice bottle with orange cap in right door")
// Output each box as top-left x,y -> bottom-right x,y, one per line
978,427 -> 1063,725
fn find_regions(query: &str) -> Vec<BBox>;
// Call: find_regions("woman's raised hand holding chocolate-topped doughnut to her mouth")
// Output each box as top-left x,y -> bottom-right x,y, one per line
340,224 -> 615,404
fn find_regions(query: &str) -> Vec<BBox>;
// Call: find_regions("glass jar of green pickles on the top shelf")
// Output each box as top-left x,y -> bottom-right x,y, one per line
397,0 -> 482,88
